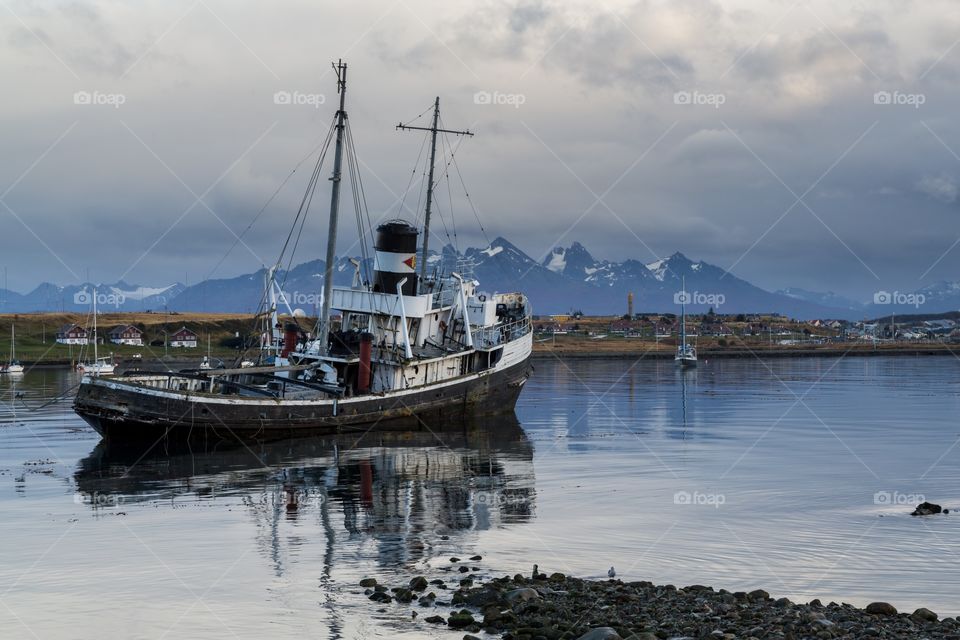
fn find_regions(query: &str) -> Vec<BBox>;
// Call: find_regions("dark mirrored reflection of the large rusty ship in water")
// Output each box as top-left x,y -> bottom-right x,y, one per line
75,414 -> 535,574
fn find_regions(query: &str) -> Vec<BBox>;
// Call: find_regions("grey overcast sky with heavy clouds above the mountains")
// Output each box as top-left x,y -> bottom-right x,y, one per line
0,0 -> 960,300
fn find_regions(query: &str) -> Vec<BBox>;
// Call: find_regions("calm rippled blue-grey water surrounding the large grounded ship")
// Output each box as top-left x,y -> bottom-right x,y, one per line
0,357 -> 960,638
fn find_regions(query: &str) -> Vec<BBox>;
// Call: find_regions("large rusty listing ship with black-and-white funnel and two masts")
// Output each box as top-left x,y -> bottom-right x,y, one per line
74,63 -> 532,440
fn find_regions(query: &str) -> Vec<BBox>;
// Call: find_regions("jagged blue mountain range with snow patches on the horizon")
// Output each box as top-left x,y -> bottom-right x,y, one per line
0,237 -> 960,320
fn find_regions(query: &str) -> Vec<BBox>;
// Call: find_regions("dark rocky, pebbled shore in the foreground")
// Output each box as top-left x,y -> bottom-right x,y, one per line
361,557 -> 960,640
